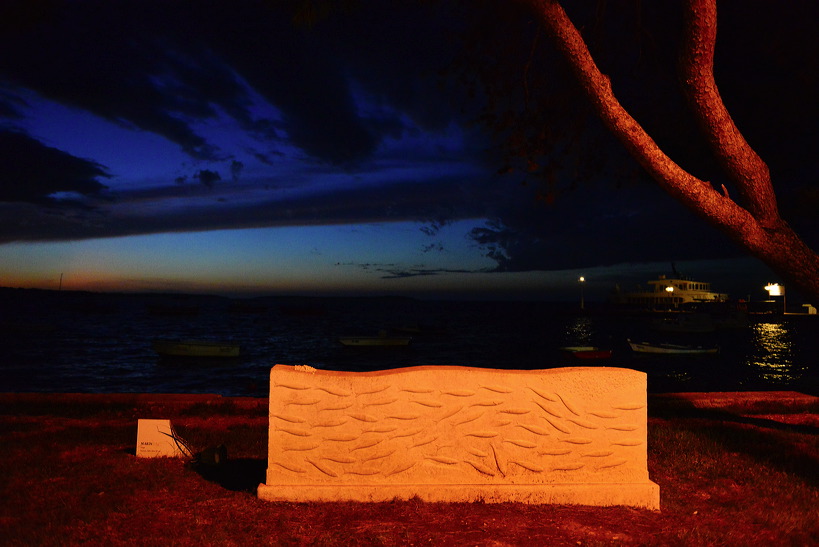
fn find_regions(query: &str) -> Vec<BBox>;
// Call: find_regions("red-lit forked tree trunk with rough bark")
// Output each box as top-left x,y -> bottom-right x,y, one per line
527,0 -> 819,304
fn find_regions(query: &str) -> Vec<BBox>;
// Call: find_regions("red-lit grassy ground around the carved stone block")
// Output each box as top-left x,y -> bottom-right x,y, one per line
0,393 -> 819,546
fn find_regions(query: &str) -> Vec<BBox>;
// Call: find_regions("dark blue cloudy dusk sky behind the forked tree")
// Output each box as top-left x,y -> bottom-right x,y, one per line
0,0 -> 819,300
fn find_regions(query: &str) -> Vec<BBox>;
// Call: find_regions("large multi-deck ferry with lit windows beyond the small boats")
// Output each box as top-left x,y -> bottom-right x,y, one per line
611,272 -> 728,309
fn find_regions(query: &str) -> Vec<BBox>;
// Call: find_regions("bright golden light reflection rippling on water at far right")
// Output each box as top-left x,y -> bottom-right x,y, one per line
747,322 -> 801,384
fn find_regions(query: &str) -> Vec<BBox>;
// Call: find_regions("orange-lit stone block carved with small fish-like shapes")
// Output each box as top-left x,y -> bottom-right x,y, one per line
258,365 -> 660,509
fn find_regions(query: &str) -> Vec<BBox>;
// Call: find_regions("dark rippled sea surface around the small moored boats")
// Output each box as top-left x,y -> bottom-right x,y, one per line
0,290 -> 819,397
